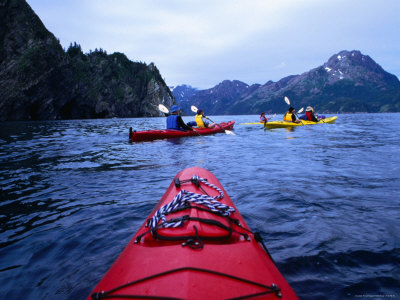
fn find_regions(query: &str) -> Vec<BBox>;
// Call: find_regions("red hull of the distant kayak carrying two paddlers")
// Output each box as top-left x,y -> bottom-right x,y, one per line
129,121 -> 235,142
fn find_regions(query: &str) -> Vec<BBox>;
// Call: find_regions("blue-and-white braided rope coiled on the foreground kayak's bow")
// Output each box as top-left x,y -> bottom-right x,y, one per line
150,175 -> 235,233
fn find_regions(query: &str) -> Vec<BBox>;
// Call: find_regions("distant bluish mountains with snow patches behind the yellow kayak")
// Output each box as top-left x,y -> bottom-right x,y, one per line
172,50 -> 400,115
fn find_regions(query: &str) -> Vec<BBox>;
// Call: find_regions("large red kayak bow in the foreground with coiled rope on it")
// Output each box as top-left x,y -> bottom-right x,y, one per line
88,167 -> 298,300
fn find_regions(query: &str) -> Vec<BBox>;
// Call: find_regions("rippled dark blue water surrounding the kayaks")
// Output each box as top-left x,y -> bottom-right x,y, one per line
0,114 -> 400,299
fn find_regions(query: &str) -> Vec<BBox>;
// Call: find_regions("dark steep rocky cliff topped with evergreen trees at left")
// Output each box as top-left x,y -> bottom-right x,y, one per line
0,0 -> 175,121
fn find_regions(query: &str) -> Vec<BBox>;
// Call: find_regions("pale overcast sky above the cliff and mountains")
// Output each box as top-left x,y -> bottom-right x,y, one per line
27,0 -> 400,89
